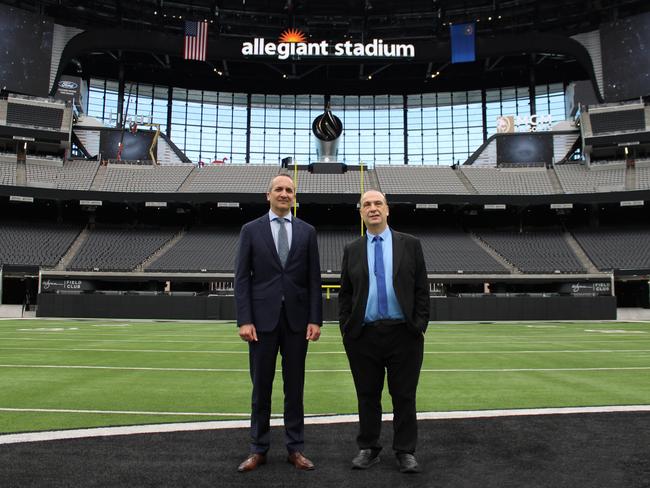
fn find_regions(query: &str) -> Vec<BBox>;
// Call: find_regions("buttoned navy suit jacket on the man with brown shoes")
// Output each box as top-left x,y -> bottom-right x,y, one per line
235,214 -> 323,332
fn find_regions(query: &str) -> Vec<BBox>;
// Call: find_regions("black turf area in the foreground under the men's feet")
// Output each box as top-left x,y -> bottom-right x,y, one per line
0,412 -> 650,488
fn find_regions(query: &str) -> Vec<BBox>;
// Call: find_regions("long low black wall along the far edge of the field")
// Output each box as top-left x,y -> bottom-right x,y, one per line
37,293 -> 616,322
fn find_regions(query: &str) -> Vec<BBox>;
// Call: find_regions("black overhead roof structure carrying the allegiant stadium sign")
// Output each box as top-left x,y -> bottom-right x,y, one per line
8,0 -> 650,94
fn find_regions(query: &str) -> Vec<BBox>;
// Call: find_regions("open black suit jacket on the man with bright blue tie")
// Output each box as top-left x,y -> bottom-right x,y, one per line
339,229 -> 429,338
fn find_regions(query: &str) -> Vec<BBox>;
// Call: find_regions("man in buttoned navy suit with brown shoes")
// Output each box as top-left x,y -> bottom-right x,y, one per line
235,174 -> 323,472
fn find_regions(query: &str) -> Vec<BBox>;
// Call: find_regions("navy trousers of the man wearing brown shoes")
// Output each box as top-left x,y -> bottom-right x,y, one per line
249,305 -> 308,453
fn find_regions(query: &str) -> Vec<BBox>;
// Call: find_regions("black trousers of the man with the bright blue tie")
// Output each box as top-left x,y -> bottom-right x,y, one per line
343,323 -> 424,453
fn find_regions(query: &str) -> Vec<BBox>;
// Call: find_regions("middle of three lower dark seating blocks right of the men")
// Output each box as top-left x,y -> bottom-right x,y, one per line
477,230 -> 586,273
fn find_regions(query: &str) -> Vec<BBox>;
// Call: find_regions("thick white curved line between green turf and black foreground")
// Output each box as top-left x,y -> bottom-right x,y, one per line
0,405 -> 650,444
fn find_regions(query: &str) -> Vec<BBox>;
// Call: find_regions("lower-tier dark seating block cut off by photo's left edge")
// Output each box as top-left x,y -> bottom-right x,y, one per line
0,222 -> 81,267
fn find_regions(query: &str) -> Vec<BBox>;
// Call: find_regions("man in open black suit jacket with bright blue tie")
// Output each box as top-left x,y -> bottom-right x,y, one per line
339,191 -> 429,473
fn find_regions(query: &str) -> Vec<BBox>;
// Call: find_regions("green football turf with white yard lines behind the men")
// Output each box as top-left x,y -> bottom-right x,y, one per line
0,320 -> 650,433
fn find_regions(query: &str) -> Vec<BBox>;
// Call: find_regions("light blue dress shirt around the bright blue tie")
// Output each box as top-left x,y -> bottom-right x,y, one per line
363,227 -> 404,322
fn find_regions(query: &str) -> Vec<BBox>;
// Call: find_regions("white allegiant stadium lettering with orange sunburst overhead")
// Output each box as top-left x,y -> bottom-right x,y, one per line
241,29 -> 415,60
